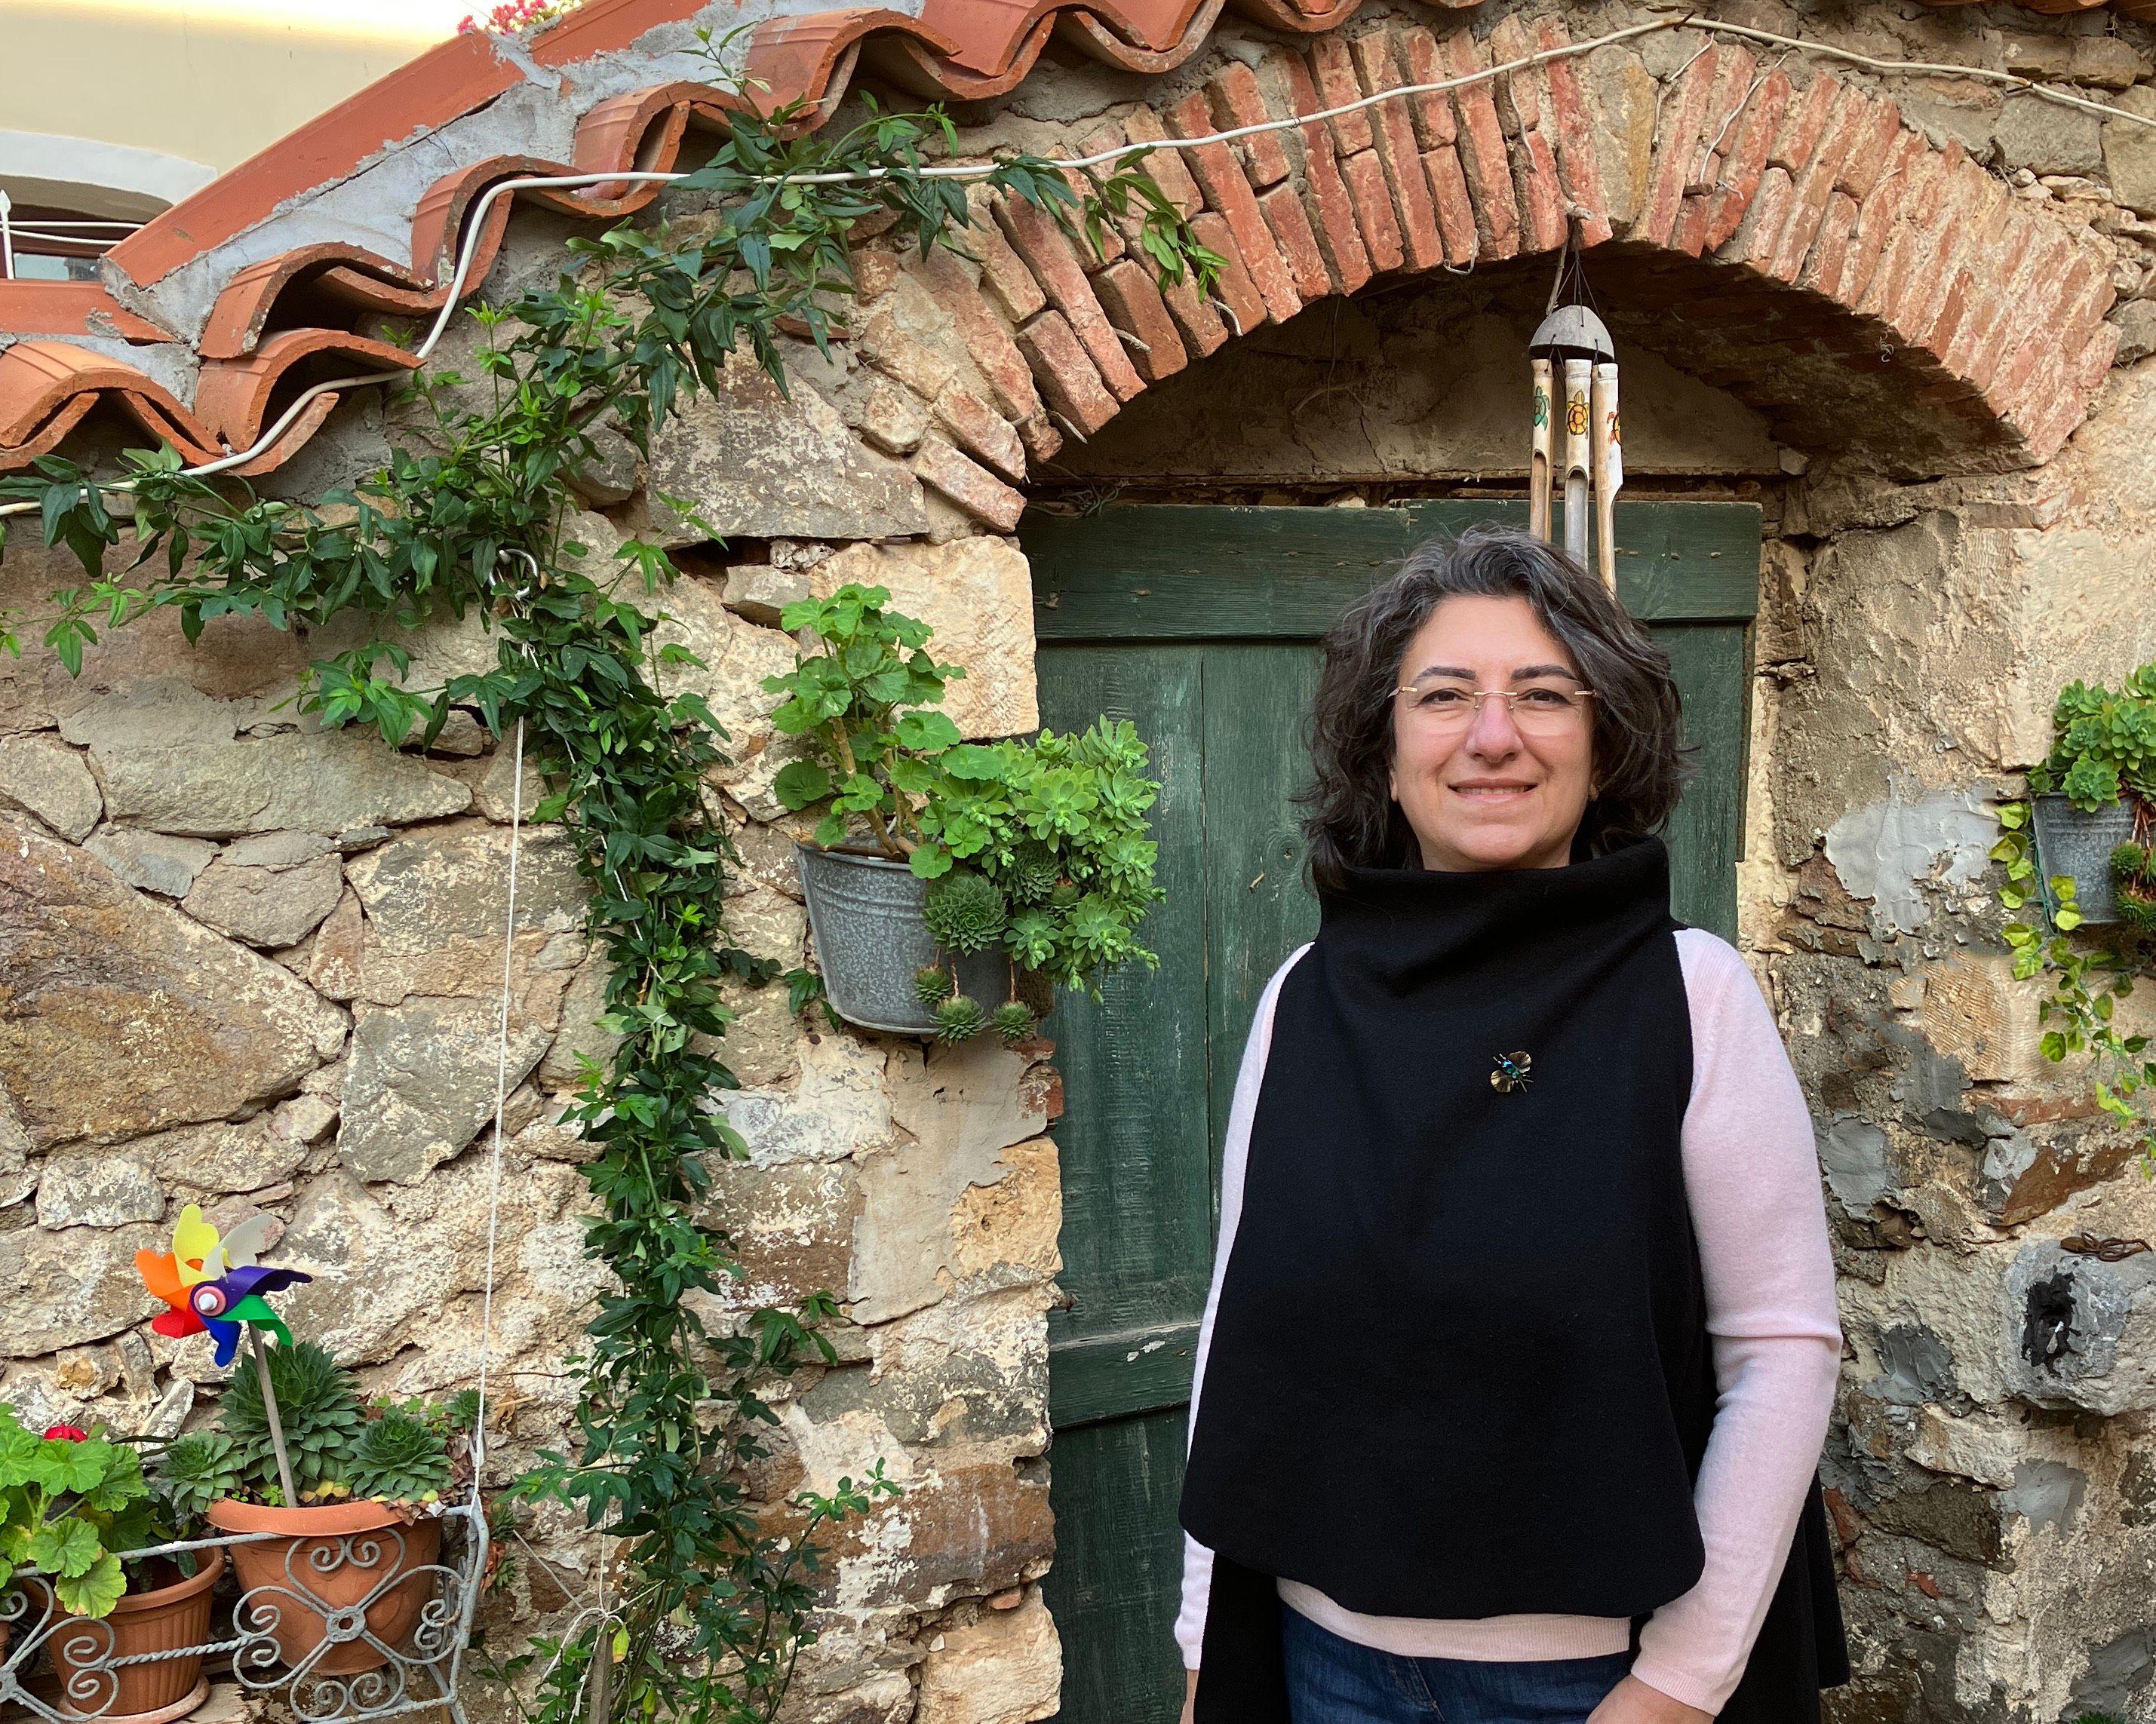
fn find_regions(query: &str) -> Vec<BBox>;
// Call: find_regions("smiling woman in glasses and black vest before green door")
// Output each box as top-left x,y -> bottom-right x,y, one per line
1175,530 -> 1847,1724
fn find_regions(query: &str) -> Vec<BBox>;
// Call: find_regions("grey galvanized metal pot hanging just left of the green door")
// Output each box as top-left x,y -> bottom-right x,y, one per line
794,842 -> 1011,1036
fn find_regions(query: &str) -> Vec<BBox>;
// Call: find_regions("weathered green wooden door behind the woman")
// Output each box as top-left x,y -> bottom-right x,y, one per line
1020,502 -> 1759,1724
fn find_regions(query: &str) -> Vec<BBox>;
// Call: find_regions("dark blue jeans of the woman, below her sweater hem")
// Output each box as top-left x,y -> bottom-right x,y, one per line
1281,1599 -> 1632,1724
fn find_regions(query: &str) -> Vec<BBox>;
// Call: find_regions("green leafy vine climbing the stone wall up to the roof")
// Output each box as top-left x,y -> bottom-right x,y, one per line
0,41 -> 1221,1724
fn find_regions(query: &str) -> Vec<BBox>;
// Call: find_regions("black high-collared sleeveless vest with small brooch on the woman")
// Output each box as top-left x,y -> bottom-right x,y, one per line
1179,836 -> 1847,1724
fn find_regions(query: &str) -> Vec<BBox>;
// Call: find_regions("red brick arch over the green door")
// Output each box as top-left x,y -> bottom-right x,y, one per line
867,17 -> 2118,504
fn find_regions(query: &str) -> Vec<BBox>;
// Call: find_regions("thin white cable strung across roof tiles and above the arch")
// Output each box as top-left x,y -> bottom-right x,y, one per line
0,15 -> 2156,517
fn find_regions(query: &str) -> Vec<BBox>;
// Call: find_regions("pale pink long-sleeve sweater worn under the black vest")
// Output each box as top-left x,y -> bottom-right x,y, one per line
1175,929 -> 1841,1713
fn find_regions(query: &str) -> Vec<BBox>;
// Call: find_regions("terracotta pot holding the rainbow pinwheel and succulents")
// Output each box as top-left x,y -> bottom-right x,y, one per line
209,1498 -> 442,1676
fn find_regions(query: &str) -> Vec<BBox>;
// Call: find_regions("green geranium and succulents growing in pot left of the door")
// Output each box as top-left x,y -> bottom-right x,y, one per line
763,586 -> 1164,1043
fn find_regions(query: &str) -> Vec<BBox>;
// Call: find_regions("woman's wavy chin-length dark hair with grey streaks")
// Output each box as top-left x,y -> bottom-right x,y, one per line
1296,526 -> 1697,890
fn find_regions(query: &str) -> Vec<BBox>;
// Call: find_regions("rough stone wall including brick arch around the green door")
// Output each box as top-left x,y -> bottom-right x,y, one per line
12,5 -> 2156,1724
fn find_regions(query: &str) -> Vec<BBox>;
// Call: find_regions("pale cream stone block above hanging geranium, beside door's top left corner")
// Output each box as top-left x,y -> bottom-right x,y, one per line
811,537 -> 1041,737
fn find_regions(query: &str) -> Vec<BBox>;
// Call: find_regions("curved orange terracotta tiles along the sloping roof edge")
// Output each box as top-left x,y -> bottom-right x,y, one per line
0,0 -> 2156,472
